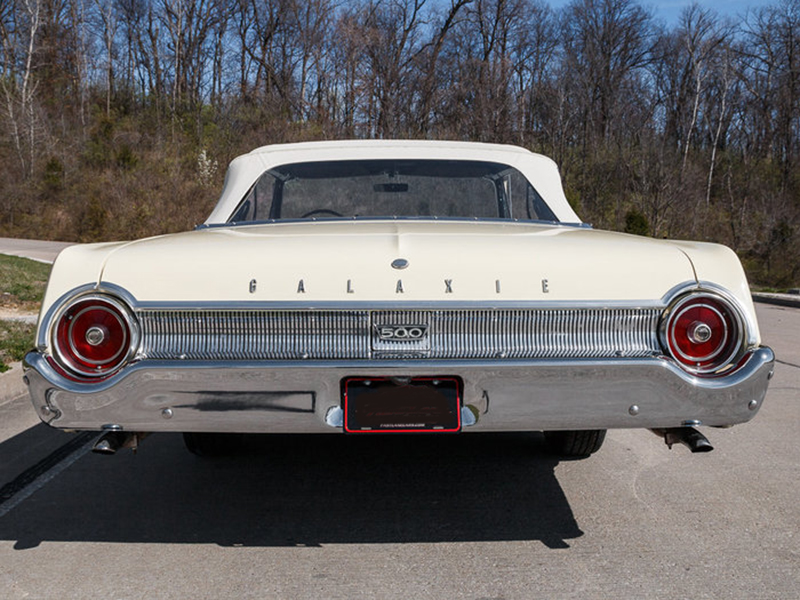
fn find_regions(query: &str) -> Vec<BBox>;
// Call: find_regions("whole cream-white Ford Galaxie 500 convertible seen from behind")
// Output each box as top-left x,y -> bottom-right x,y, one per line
25,141 -> 774,456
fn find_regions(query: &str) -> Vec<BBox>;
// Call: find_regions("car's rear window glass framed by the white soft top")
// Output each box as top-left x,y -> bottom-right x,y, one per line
229,160 -> 557,223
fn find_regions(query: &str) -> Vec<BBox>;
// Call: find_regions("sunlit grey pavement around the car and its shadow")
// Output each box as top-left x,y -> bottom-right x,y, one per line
0,305 -> 800,600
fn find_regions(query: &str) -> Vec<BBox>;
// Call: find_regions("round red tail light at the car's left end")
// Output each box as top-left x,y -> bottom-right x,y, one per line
53,296 -> 135,377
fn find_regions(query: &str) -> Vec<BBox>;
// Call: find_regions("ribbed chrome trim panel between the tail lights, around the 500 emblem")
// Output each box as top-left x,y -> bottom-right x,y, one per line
136,308 -> 661,360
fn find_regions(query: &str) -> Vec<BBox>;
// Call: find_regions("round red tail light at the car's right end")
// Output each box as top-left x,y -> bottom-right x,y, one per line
664,293 -> 743,373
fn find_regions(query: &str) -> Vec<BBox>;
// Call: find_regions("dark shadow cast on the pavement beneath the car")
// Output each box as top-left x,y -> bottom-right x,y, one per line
0,434 -> 583,549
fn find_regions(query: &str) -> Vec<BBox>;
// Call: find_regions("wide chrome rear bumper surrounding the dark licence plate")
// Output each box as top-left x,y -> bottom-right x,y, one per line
25,347 -> 774,433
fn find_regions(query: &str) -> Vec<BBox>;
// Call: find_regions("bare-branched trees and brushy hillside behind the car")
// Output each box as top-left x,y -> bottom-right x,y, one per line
0,0 -> 800,286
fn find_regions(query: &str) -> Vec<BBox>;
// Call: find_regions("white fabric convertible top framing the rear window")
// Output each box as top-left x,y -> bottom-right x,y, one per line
206,140 -> 581,224
